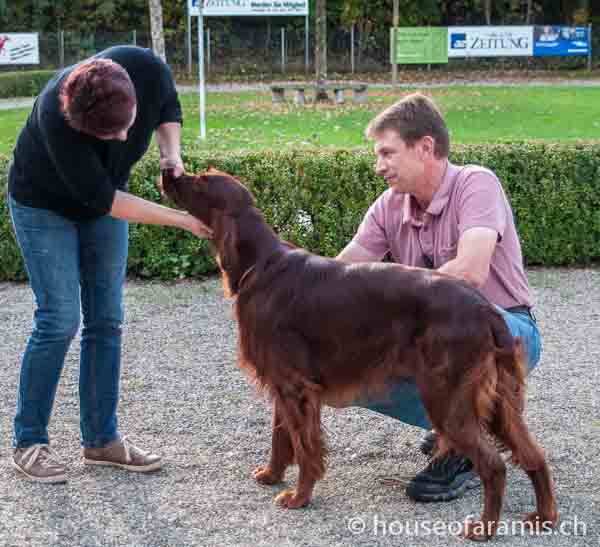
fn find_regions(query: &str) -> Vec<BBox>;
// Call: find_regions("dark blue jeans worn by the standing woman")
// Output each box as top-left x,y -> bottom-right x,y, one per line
9,196 -> 128,448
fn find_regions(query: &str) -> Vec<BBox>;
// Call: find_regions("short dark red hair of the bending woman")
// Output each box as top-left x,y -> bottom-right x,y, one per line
60,59 -> 136,136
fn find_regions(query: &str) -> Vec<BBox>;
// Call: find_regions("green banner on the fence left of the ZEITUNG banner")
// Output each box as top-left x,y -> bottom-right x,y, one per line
390,27 -> 448,64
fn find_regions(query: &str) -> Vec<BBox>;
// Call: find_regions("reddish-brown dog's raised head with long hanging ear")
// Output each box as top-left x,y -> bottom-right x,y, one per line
161,169 -> 254,295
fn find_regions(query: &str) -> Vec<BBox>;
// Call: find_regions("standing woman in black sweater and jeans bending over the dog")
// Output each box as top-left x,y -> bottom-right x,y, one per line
8,46 -> 210,483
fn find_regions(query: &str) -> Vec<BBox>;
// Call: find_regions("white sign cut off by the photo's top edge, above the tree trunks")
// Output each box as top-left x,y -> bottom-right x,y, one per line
188,0 -> 308,17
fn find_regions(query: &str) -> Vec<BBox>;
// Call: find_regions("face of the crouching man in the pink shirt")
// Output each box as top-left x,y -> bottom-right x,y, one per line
375,129 -> 432,194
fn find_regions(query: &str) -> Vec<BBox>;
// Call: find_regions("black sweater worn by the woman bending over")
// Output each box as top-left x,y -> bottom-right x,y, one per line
8,46 -> 182,220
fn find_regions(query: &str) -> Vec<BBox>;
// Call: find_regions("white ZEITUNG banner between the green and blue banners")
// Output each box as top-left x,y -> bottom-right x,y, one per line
448,26 -> 533,57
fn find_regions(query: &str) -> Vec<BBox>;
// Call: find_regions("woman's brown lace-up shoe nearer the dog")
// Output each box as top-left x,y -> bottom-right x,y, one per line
83,437 -> 162,473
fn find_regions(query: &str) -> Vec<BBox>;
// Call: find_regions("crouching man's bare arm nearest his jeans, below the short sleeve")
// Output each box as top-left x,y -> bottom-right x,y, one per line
438,228 -> 498,288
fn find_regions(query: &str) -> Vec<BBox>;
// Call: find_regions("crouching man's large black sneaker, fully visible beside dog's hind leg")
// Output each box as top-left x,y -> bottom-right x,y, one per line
406,454 -> 481,501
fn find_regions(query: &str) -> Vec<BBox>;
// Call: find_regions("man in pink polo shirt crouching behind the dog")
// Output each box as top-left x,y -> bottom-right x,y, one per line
338,94 -> 541,501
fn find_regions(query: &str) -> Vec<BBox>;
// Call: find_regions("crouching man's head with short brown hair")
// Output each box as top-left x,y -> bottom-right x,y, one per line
366,93 -> 450,194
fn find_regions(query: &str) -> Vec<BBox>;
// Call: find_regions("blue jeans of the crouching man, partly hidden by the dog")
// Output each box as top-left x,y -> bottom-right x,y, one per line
357,308 -> 542,429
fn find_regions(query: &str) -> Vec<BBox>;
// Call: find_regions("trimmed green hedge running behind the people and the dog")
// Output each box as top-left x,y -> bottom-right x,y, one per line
0,143 -> 600,280
